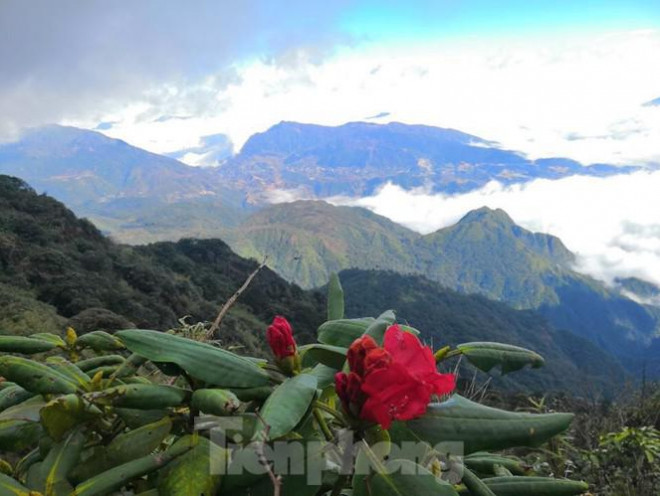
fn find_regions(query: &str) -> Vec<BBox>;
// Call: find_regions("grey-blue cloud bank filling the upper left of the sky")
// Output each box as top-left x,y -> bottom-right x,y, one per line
0,0 -> 345,141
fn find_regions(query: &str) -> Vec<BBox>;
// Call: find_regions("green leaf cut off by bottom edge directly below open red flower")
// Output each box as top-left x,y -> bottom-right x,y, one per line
353,460 -> 458,496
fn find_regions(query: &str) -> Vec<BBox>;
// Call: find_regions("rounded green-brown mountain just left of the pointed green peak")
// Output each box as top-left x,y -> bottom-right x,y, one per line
225,201 -> 419,288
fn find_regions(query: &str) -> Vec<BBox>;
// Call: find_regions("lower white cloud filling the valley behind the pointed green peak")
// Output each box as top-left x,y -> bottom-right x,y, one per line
333,171 -> 660,284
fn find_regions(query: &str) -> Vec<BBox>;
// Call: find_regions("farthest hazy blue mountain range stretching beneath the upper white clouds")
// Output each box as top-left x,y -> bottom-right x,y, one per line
0,122 -> 639,244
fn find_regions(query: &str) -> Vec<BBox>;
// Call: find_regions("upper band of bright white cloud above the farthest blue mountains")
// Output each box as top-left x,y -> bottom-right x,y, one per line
89,30 -> 660,164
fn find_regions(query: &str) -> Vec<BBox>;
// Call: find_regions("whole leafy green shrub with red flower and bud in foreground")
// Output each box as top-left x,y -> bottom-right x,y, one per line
0,279 -> 587,496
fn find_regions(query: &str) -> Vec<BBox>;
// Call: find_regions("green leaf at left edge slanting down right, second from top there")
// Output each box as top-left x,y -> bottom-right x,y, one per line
0,356 -> 78,394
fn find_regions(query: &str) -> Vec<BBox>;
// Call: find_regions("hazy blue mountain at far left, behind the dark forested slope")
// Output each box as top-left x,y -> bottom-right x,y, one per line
0,125 -> 249,241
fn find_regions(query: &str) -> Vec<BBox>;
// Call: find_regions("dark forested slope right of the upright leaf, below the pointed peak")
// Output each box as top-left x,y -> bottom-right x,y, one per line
340,269 -> 627,395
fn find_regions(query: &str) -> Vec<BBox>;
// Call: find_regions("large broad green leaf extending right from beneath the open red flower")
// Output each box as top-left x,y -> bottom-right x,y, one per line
406,395 -> 573,454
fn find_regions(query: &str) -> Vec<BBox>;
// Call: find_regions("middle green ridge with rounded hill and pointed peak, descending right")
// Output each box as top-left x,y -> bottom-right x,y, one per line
228,201 -> 660,370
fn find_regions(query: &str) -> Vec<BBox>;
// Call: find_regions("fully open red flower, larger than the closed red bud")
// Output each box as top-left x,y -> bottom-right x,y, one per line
335,325 -> 455,429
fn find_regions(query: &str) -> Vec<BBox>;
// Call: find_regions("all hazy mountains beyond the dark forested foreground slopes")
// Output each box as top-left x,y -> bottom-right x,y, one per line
0,123 -> 660,380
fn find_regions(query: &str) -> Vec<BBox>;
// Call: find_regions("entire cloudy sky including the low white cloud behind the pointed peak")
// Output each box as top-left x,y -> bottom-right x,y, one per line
0,0 -> 660,283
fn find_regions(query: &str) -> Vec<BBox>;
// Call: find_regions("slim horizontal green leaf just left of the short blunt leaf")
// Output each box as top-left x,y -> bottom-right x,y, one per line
84,384 -> 191,410
